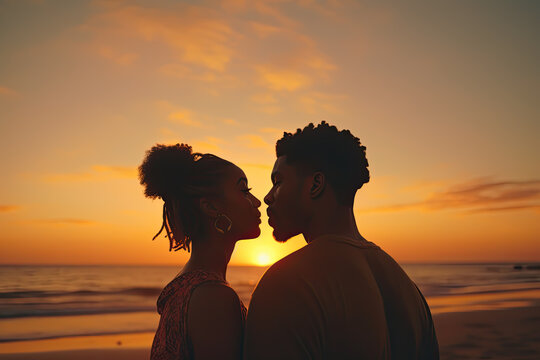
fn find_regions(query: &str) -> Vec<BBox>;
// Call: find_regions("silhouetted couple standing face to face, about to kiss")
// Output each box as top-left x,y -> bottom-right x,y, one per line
139,121 -> 439,360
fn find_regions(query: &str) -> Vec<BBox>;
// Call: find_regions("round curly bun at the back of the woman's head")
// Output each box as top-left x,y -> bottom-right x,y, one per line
139,144 -> 196,199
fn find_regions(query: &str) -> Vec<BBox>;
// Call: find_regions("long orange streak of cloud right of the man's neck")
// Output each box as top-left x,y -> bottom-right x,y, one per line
360,178 -> 540,214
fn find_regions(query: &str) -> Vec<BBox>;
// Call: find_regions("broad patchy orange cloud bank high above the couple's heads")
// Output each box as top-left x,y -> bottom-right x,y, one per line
81,1 -> 339,95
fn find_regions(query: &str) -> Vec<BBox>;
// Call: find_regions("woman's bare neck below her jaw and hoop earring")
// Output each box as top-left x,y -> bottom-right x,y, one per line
181,239 -> 235,280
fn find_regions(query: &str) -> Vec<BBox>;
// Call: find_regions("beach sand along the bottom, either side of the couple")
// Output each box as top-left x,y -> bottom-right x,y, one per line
0,304 -> 540,360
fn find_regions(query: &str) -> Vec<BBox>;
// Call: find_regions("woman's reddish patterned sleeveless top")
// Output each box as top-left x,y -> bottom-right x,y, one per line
150,270 -> 246,360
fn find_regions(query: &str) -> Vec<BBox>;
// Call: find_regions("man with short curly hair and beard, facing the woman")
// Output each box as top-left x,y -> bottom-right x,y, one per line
244,121 -> 439,360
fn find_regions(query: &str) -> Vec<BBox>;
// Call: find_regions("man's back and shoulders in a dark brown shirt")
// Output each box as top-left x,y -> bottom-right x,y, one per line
244,236 -> 438,359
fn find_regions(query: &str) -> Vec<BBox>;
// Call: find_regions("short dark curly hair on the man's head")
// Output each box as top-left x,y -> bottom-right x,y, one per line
276,121 -> 369,205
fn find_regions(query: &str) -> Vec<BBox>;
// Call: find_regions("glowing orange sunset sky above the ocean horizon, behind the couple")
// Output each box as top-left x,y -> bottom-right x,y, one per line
0,0 -> 540,266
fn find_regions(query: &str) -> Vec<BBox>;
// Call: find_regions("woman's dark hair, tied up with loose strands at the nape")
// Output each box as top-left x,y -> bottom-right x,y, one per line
139,144 -> 233,252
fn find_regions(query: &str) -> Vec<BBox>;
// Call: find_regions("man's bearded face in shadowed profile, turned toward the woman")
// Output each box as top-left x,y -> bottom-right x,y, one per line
264,156 -> 309,242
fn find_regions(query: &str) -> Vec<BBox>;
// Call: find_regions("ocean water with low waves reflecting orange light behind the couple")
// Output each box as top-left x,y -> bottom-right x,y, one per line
0,264 -> 540,343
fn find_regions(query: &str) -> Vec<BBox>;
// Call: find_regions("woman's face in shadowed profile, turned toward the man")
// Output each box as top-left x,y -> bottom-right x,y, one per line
218,166 -> 261,240
